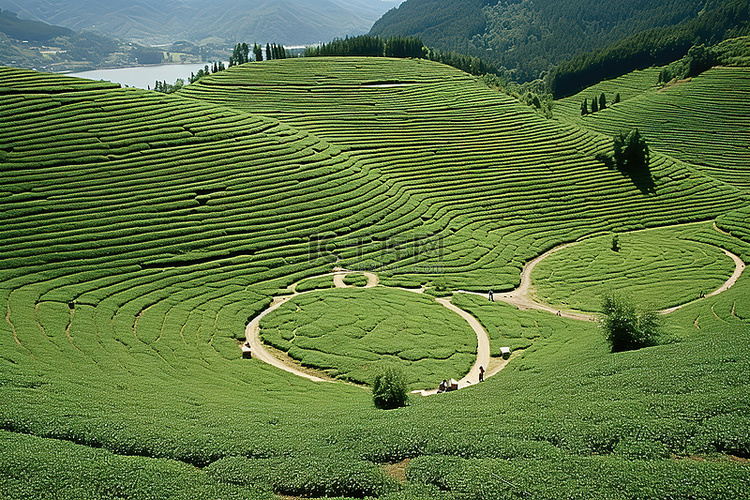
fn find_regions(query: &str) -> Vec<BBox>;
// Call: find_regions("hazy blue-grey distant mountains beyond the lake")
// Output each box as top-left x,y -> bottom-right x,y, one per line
0,0 -> 401,45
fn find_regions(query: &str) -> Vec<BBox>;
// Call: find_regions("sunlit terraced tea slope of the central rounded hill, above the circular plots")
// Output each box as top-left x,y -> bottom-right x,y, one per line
180,58 -> 745,290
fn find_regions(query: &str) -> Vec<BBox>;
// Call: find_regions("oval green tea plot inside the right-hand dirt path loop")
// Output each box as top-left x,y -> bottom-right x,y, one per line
531,224 -> 735,312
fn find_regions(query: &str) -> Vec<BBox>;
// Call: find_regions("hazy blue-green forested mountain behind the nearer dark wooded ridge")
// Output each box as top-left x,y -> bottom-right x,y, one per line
370,0 -> 747,81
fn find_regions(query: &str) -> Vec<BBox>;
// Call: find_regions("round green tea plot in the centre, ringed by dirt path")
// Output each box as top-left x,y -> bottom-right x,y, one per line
261,288 -> 477,389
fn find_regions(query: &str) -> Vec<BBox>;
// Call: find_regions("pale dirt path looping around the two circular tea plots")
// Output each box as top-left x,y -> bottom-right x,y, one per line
245,232 -> 745,396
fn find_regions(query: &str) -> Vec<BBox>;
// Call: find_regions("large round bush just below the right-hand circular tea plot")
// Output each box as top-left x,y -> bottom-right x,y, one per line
601,293 -> 659,352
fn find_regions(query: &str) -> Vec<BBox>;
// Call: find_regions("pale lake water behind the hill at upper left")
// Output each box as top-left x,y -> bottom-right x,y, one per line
66,62 -> 229,89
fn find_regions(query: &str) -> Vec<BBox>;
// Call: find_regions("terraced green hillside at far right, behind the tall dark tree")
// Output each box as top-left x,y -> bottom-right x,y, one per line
555,67 -> 750,191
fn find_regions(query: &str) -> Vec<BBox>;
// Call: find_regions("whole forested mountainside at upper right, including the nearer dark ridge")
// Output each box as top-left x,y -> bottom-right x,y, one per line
370,0 -> 748,86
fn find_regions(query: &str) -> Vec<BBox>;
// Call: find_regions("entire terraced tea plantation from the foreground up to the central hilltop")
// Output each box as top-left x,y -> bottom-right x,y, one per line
0,58 -> 750,499
